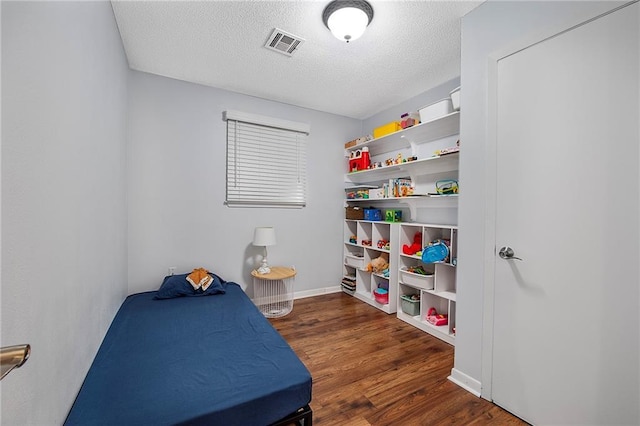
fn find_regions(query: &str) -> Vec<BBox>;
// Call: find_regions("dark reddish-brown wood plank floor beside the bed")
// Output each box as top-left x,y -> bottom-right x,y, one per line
271,293 -> 526,426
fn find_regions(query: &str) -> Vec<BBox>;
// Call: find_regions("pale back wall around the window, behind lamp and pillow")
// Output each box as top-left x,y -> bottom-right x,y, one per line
128,72 -> 361,295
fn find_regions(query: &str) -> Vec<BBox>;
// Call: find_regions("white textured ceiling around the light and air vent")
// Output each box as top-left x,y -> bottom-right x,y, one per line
112,0 -> 481,119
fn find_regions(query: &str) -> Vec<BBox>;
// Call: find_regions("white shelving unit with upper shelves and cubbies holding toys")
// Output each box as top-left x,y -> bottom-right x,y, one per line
343,112 -> 460,344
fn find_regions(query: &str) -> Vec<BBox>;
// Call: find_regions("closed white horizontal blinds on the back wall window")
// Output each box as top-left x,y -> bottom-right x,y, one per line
225,111 -> 309,207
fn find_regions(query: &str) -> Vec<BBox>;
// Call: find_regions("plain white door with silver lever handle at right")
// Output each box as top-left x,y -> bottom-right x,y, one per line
491,3 -> 640,425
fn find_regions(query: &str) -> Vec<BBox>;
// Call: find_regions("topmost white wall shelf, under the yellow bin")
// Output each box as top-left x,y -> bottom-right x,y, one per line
347,111 -> 460,156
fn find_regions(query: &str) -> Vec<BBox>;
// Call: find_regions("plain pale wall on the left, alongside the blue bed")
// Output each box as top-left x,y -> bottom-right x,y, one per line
0,1 -> 128,425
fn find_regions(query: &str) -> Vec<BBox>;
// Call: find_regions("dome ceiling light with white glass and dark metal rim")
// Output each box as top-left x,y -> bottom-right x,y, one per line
322,0 -> 373,43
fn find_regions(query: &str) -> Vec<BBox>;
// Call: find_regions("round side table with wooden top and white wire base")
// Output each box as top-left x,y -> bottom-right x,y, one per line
251,266 -> 296,318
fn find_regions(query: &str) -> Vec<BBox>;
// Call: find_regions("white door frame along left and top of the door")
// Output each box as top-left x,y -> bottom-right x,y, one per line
480,0 -> 640,401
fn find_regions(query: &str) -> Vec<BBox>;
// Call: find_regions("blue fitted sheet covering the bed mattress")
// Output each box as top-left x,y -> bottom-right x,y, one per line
65,283 -> 311,426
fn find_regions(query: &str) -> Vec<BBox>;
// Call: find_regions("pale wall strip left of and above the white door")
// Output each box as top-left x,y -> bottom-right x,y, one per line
455,1 -> 623,397
